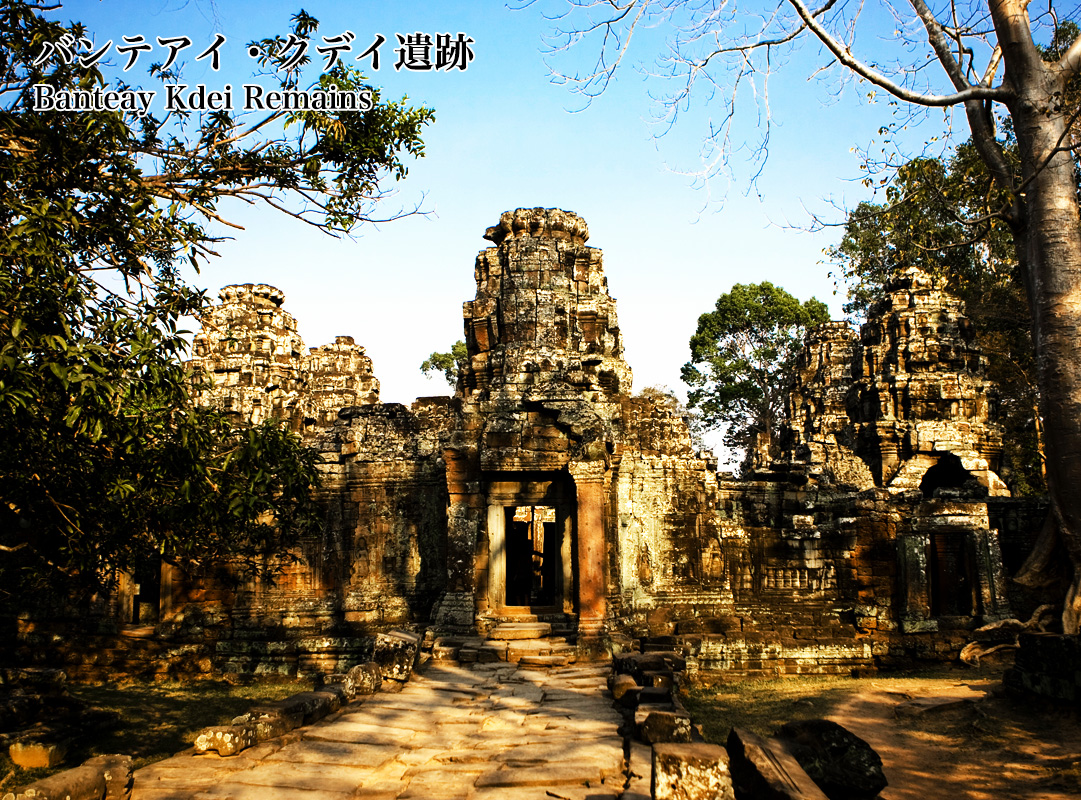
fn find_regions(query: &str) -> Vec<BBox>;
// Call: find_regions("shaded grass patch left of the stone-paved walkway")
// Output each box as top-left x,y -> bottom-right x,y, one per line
0,681 -> 311,794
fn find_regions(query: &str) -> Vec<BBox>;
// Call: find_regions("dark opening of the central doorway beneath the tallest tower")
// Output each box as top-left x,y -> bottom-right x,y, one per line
505,506 -> 560,605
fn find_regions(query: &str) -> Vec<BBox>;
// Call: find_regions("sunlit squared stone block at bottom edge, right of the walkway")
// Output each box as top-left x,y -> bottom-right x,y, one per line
650,744 -> 736,800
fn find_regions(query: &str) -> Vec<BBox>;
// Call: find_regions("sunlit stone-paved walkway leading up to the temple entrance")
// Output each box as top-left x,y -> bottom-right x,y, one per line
133,663 -> 625,800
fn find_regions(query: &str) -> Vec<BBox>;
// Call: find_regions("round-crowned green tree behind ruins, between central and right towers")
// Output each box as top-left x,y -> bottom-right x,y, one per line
682,281 -> 829,461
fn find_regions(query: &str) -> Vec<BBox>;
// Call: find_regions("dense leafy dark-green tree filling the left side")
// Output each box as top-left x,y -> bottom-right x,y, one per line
0,2 -> 431,600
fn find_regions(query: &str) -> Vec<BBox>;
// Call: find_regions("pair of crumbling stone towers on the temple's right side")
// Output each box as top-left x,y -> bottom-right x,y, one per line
788,268 -> 1009,496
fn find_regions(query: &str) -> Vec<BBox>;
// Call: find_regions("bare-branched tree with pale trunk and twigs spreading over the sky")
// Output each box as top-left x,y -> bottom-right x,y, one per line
540,0 -> 1081,634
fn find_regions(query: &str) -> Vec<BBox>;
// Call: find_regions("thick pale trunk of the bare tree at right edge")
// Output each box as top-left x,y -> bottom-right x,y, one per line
990,0 -> 1081,634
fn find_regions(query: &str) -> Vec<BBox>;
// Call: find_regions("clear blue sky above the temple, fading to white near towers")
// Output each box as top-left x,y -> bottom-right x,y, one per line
55,0 -> 964,430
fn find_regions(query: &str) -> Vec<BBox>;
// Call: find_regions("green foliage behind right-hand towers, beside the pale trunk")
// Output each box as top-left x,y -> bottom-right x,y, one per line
826,144 -> 1044,495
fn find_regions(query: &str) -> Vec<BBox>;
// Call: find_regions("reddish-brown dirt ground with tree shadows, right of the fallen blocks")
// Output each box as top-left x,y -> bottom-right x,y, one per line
690,670 -> 1081,800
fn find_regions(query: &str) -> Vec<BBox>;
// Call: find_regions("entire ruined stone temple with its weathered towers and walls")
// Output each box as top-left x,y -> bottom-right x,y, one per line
120,209 -> 1042,674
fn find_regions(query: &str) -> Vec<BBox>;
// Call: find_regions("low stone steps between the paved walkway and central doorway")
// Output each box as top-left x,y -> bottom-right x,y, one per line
431,614 -> 577,669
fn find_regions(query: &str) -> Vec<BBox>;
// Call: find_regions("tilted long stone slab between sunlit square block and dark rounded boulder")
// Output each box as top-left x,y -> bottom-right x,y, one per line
726,728 -> 829,800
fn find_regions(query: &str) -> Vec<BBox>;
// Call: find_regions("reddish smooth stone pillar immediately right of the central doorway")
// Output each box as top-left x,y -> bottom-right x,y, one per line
569,461 -> 608,638
